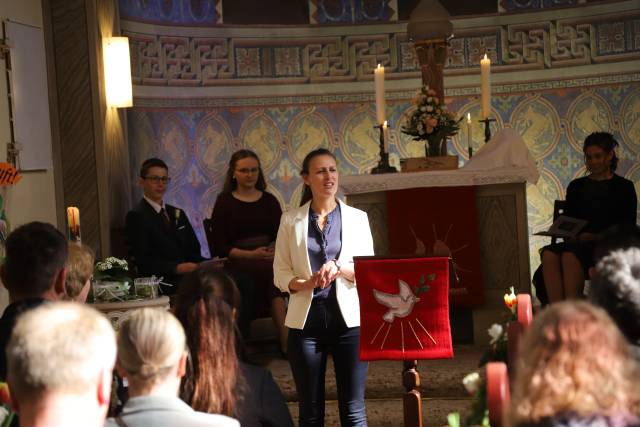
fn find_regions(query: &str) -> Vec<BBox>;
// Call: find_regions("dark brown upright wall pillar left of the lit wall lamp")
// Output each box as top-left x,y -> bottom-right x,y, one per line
47,0 -> 102,254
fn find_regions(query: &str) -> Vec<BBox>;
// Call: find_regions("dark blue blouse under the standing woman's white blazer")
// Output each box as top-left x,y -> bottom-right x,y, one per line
307,204 -> 342,299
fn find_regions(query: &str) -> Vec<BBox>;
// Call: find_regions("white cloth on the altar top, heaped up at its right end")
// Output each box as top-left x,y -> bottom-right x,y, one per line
340,128 -> 539,195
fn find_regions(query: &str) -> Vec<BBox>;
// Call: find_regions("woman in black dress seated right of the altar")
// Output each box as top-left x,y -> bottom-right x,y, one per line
541,132 -> 638,303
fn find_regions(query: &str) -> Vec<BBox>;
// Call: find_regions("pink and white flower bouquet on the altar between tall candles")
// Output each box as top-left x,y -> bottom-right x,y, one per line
401,86 -> 462,157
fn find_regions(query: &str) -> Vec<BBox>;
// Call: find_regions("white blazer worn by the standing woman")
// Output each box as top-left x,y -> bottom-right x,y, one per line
273,200 -> 373,329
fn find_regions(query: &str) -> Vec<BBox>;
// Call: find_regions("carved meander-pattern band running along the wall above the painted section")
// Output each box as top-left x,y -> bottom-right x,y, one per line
124,11 -> 640,86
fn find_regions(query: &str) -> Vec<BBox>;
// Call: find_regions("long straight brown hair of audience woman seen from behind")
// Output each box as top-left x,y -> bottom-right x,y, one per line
174,266 -> 241,416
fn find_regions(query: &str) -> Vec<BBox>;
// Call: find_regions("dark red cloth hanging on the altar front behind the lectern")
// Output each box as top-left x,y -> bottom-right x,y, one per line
387,186 -> 484,307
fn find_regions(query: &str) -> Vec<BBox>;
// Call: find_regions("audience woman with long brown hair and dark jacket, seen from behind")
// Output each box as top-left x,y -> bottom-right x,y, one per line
174,265 -> 293,427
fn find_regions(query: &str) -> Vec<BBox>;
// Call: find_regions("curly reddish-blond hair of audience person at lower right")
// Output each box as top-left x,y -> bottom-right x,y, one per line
508,301 -> 640,427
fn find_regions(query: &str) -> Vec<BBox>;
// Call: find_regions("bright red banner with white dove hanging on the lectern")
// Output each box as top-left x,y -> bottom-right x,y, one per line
355,257 -> 453,360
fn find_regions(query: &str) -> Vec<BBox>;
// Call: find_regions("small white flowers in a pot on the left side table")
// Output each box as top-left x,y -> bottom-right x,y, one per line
92,257 -> 131,302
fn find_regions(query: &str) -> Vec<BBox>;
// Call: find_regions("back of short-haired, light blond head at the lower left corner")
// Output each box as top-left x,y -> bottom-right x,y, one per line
7,302 -> 116,427
